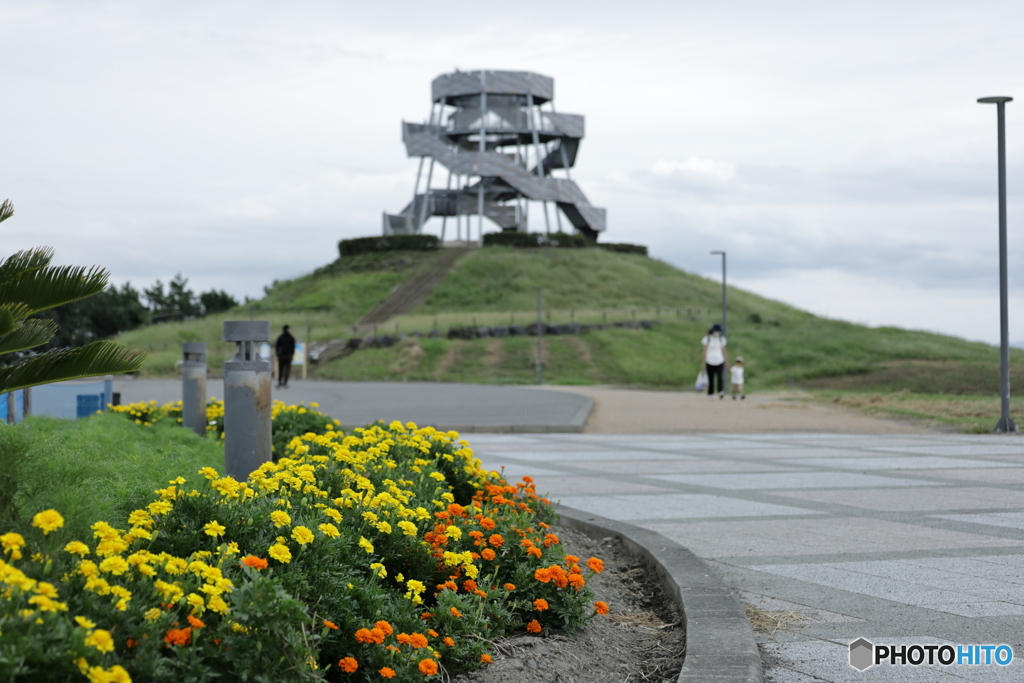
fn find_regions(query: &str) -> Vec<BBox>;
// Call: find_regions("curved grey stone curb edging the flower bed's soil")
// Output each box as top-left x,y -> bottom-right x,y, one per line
555,505 -> 764,683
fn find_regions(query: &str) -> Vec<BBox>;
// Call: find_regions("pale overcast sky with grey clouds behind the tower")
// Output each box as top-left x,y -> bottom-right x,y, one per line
0,0 -> 1024,343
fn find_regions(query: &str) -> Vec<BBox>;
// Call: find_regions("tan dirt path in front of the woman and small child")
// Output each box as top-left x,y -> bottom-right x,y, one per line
537,386 -> 934,434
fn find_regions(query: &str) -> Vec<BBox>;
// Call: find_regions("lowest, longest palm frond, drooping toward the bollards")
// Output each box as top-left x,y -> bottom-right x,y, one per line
0,341 -> 145,392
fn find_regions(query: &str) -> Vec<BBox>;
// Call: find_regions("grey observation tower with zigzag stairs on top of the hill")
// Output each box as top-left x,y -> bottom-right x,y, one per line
384,71 -> 605,241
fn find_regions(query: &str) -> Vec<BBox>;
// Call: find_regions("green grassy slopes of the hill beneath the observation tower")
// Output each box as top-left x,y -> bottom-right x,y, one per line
114,247 -> 1024,401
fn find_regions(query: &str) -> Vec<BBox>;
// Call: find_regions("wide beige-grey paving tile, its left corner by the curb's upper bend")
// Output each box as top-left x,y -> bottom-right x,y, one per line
641,518 -> 1019,557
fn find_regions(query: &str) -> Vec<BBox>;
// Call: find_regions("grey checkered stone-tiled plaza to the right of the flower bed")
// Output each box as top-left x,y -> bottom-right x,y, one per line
469,434 -> 1024,683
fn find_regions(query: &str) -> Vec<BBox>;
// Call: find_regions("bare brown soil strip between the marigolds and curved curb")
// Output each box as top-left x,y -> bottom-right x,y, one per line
452,527 -> 686,683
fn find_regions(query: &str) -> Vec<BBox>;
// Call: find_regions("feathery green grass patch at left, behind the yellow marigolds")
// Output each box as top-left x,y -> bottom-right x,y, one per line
0,413 -> 224,539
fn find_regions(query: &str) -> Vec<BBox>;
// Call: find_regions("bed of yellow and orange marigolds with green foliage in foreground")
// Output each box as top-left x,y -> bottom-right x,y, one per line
0,411 -> 605,683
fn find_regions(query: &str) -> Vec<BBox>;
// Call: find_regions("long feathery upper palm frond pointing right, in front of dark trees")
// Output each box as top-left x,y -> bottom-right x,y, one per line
0,265 -> 110,312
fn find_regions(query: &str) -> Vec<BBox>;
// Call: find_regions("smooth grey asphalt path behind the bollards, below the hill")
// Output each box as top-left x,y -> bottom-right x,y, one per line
114,379 -> 594,432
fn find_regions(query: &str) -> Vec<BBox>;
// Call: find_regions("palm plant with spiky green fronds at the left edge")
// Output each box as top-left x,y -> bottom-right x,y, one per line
0,200 -> 145,392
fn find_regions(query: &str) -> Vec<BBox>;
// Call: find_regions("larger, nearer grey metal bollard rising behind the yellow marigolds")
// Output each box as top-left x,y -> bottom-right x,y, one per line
224,321 -> 271,481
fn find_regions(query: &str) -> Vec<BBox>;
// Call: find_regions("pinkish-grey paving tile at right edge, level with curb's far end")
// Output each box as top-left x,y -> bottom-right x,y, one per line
778,486 -> 1024,512
